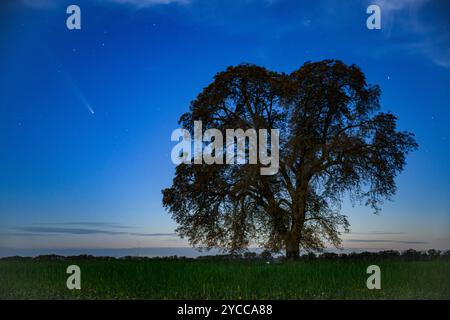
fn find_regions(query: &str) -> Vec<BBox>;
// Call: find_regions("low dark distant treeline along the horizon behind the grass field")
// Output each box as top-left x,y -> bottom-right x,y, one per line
0,249 -> 450,263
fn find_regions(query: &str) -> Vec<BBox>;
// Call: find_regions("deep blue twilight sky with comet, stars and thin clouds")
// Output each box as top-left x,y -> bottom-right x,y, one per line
0,0 -> 450,255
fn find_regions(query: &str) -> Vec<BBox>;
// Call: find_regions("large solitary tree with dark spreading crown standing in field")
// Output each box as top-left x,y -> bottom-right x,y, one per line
163,60 -> 417,259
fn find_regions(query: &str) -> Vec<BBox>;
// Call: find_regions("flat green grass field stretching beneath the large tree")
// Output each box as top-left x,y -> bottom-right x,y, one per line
0,260 -> 450,299
